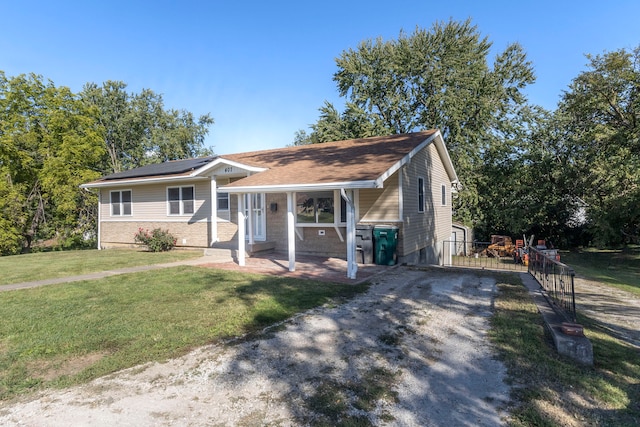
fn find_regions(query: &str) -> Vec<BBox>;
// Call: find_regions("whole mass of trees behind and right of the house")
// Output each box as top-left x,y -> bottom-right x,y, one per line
300,20 -> 640,245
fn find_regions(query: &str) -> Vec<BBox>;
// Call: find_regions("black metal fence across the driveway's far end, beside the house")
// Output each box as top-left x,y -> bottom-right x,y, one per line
441,240 -> 527,271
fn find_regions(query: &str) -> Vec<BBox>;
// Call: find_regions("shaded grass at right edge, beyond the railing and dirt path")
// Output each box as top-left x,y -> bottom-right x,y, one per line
561,246 -> 640,295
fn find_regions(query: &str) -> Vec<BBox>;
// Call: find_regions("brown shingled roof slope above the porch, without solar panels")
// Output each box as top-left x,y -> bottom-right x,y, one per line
221,130 -> 436,189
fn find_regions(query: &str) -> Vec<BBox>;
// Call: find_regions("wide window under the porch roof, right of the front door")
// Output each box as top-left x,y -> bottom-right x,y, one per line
296,191 -> 347,225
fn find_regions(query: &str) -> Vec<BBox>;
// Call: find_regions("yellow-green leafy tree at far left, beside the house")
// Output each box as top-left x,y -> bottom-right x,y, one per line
0,72 -> 104,254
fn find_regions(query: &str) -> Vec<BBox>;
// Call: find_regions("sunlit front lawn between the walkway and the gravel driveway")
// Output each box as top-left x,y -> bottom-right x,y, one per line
0,267 -> 366,400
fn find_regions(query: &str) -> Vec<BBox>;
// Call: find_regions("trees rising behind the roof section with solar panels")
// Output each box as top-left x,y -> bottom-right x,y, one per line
80,81 -> 213,172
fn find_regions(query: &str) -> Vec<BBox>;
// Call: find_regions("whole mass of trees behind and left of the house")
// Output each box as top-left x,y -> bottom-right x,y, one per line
0,71 -> 213,254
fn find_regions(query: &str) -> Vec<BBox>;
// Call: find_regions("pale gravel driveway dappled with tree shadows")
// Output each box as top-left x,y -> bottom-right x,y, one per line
0,267 -> 509,426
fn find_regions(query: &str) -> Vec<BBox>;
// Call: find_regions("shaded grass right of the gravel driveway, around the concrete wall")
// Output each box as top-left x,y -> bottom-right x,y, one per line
490,275 -> 640,426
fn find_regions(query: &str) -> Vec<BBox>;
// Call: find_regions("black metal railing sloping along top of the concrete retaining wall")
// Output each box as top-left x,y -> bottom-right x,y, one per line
528,248 -> 576,322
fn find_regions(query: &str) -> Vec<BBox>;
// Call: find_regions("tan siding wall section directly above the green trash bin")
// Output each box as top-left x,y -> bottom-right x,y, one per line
358,172 -> 400,222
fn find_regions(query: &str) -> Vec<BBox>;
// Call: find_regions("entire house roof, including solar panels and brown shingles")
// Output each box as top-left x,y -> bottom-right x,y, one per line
82,130 -> 457,192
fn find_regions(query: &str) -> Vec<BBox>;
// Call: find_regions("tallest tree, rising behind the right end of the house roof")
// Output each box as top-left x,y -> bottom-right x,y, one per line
294,20 -> 534,224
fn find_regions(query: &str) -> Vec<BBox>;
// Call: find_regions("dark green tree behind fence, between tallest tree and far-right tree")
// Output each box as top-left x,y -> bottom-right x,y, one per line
476,107 -> 582,246
